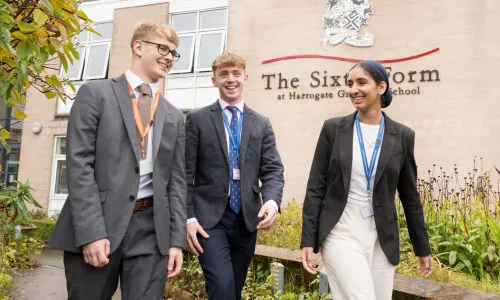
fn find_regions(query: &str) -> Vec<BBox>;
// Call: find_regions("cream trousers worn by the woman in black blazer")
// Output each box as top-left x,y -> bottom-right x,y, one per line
321,203 -> 395,300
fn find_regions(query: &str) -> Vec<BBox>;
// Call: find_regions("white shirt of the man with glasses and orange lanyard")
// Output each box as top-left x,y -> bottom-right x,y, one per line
125,71 -> 160,200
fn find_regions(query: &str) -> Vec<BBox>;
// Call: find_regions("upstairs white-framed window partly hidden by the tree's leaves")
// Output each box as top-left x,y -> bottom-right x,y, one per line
61,22 -> 113,81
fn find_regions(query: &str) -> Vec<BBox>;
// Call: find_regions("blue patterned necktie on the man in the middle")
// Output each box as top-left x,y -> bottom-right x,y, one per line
227,106 -> 241,213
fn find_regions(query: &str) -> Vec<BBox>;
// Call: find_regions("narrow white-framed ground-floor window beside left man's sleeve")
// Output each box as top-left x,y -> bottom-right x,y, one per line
49,136 -> 68,216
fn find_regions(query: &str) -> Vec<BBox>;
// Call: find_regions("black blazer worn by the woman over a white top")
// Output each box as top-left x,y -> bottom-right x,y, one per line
300,113 -> 431,265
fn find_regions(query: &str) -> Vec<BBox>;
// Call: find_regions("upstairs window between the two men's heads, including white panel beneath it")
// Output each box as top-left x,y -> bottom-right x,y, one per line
165,7 -> 227,110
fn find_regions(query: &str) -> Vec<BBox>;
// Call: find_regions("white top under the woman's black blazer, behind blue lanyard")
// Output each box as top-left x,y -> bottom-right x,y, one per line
347,122 -> 382,205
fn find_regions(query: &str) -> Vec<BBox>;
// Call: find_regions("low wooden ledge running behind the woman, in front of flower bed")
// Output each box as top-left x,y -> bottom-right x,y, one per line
255,245 -> 500,300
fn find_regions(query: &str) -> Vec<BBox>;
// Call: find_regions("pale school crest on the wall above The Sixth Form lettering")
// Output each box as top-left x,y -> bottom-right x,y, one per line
321,0 -> 375,49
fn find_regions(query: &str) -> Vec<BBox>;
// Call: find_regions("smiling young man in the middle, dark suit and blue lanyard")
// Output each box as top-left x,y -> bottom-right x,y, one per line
186,53 -> 284,300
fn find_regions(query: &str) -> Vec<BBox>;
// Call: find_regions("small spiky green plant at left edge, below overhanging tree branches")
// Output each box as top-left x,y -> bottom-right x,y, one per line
0,180 -> 42,221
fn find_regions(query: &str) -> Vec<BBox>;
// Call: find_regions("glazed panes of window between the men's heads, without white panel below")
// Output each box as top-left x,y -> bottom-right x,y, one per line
170,8 -> 227,74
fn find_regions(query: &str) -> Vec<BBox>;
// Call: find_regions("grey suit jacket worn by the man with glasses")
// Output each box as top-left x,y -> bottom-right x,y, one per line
49,75 -> 187,255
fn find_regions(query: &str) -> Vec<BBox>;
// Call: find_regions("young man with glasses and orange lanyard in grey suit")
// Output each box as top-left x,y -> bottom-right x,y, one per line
49,23 -> 187,300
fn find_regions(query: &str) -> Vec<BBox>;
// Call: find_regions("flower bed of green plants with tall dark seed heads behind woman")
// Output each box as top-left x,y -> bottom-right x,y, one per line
257,161 -> 500,294
